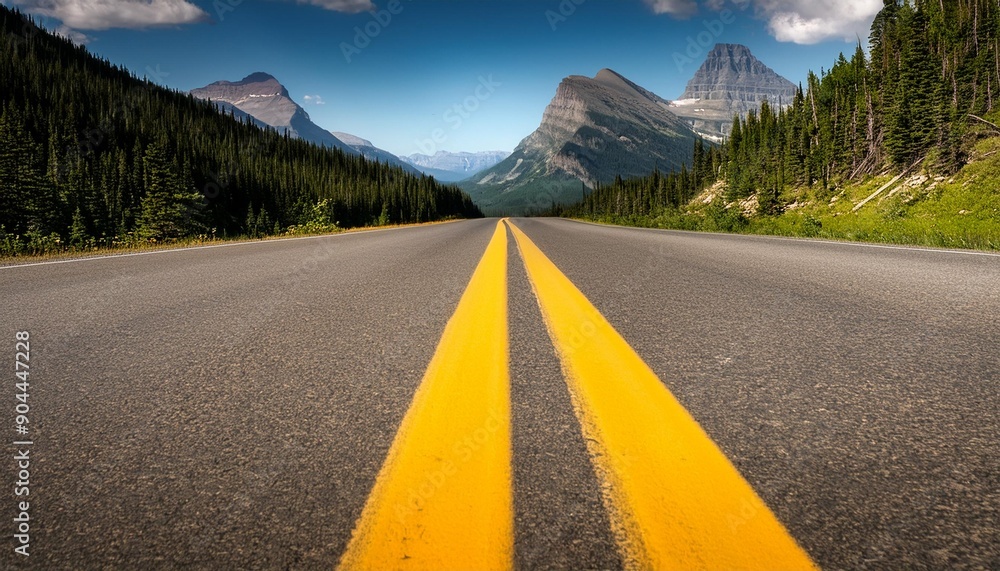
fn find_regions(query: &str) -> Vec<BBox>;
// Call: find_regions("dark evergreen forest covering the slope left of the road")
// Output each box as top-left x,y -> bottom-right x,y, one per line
0,6 -> 482,254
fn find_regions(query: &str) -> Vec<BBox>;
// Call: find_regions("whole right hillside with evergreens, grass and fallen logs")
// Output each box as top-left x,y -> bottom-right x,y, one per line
569,0 -> 1000,248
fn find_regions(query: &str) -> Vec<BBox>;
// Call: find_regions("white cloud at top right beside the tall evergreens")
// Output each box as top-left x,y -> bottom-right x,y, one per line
644,0 -> 883,44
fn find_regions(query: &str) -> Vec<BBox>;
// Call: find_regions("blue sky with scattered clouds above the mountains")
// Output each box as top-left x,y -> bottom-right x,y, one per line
4,0 -> 882,155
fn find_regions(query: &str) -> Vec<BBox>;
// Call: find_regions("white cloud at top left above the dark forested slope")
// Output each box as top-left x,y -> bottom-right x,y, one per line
13,0 -> 209,30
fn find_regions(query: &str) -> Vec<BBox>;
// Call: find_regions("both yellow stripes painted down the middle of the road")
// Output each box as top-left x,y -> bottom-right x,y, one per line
340,220 -> 816,570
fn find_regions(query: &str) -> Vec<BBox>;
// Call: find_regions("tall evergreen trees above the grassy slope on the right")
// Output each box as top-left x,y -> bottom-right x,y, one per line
568,0 -> 1000,221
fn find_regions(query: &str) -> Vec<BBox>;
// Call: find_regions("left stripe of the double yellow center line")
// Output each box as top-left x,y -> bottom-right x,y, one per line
340,221 -> 514,570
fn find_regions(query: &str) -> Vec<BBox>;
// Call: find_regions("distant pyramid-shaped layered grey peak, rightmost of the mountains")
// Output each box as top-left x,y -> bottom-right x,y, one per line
670,44 -> 798,141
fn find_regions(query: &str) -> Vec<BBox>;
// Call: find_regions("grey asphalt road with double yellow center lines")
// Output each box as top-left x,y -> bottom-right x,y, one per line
0,219 -> 1000,569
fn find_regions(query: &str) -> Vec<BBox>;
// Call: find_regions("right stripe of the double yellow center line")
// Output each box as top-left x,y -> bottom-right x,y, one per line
508,221 -> 816,570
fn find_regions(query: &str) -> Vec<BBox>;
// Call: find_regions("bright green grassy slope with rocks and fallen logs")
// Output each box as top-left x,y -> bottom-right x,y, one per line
580,137 -> 1000,250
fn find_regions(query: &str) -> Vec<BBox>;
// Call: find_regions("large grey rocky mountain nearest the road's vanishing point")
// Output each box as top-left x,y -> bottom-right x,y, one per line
460,69 -> 697,213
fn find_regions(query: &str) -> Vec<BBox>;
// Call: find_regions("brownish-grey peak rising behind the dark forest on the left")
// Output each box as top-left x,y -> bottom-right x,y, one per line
191,72 -> 359,155
